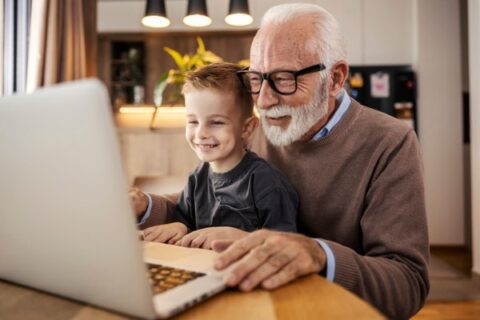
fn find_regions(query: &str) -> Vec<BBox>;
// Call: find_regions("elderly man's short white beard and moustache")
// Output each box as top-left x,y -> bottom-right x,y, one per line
257,81 -> 328,146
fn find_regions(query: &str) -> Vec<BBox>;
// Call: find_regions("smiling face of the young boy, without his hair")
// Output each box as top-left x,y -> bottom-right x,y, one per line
185,89 -> 246,172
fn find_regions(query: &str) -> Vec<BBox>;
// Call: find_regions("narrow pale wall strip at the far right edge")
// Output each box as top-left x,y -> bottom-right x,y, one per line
468,0 -> 480,274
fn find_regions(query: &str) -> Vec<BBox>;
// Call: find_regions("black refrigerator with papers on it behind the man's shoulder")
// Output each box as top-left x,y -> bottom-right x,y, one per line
346,65 -> 418,130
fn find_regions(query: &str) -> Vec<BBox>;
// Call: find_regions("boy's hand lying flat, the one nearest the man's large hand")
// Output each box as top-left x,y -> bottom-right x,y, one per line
175,227 -> 248,249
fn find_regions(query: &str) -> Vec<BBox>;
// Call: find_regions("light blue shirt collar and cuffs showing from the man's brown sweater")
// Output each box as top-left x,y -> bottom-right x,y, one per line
138,90 -> 352,282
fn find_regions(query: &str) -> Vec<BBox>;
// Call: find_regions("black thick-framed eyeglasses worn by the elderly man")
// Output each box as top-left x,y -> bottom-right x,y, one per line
237,63 -> 326,95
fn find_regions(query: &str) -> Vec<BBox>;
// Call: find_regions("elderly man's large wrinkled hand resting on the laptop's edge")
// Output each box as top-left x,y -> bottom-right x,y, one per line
212,229 -> 326,291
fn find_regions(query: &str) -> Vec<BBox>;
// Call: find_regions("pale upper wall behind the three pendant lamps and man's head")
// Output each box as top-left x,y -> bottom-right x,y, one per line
97,0 -> 415,64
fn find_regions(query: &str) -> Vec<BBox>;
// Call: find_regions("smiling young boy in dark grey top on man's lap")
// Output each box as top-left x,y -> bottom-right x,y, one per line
144,63 -> 298,248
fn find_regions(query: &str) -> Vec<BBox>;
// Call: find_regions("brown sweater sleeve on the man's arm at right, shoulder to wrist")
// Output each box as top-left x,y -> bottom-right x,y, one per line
327,131 -> 429,319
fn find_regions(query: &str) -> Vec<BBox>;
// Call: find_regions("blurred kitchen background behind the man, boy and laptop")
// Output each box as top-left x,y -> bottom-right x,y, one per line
0,0 -> 480,314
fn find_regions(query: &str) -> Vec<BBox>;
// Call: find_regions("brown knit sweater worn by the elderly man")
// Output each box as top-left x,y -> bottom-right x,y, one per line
142,100 -> 429,319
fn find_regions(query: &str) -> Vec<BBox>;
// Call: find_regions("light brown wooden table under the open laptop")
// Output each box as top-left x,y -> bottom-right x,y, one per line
0,246 -> 384,320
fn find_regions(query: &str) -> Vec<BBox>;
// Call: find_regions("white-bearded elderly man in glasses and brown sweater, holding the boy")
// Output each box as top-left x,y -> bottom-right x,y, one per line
132,4 -> 429,319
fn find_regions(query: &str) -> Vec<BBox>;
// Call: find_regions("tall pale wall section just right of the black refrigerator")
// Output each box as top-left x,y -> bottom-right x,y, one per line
415,0 -> 465,245
